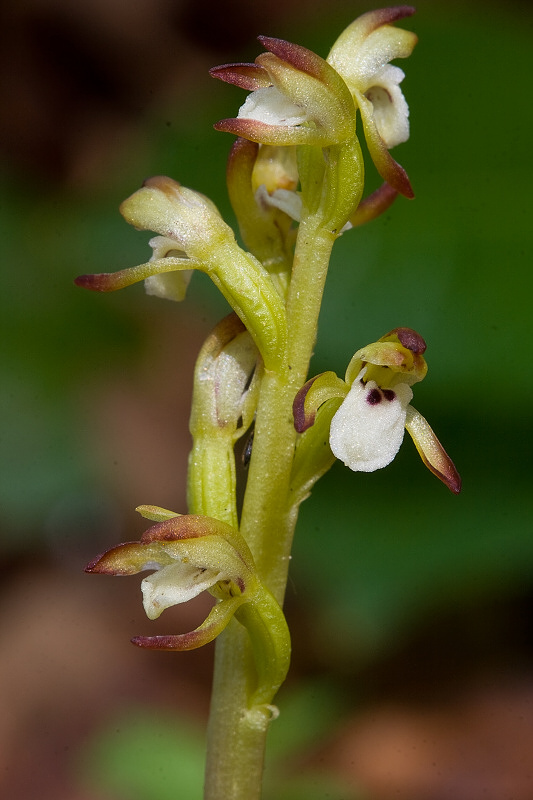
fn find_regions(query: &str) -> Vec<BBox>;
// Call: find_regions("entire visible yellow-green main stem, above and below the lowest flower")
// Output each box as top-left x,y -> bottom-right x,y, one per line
205,217 -> 335,800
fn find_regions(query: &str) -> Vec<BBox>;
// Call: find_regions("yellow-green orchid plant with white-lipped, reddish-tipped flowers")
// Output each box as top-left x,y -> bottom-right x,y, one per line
76,6 -> 460,800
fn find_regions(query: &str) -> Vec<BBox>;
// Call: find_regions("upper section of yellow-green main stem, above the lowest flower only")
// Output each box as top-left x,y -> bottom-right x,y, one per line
241,217 -> 335,592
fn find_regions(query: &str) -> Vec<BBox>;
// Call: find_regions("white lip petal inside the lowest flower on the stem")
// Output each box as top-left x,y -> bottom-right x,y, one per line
141,561 -> 223,619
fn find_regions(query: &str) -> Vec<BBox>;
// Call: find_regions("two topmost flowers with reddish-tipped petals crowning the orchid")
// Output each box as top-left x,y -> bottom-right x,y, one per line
211,6 -> 417,197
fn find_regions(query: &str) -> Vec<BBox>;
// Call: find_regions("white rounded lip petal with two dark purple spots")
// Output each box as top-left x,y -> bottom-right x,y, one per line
329,379 -> 413,472
